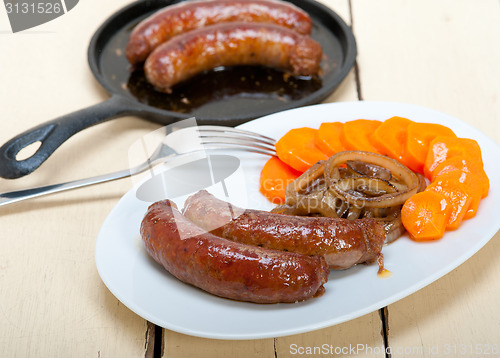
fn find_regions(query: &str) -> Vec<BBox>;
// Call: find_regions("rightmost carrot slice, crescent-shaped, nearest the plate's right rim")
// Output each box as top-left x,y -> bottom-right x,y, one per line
430,156 -> 490,199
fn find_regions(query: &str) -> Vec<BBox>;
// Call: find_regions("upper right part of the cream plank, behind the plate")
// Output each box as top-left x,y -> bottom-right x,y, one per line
352,0 -> 500,136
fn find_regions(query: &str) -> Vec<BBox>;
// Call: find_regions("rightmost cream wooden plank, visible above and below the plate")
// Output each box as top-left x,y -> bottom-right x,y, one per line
352,0 -> 500,357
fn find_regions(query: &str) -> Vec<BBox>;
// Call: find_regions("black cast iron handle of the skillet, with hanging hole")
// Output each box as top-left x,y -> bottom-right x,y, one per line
0,95 -> 135,179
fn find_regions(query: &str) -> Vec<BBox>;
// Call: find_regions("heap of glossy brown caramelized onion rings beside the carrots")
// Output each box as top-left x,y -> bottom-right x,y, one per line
272,151 -> 426,243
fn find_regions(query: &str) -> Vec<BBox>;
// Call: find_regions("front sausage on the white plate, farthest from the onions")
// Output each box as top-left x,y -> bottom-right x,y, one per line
141,200 -> 328,303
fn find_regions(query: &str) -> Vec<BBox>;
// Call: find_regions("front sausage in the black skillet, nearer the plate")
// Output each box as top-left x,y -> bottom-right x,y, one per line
144,22 -> 322,92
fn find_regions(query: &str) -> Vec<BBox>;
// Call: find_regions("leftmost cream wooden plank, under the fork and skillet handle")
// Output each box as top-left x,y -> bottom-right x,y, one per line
0,0 -> 151,357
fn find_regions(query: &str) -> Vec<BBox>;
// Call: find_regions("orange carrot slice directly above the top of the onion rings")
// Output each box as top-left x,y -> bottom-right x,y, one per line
340,119 -> 382,153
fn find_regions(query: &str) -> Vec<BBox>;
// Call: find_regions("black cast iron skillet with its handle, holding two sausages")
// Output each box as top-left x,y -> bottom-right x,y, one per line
0,0 -> 356,179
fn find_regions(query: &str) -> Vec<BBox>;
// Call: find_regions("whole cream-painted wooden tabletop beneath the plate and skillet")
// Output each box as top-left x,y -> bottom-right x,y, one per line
0,0 -> 500,358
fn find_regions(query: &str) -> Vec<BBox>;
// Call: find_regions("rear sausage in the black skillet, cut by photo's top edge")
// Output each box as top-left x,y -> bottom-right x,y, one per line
125,0 -> 312,64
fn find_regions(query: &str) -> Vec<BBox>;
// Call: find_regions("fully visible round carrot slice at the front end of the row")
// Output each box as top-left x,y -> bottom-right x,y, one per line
401,191 -> 451,241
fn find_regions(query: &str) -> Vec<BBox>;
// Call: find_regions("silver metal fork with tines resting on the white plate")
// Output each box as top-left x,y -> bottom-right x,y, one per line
0,126 -> 276,206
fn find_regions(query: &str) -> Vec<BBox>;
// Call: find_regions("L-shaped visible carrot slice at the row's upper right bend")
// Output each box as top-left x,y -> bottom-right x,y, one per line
403,123 -> 456,173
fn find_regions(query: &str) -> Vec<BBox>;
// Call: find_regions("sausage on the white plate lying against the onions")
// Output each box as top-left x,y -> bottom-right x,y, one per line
184,191 -> 385,269
